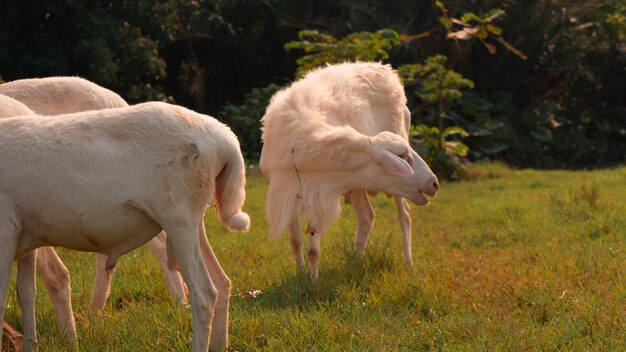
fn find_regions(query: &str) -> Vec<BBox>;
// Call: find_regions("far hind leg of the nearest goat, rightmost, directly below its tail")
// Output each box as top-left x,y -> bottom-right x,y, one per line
199,223 -> 231,351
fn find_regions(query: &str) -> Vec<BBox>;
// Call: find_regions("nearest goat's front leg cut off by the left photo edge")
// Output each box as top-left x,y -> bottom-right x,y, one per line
0,193 -> 21,349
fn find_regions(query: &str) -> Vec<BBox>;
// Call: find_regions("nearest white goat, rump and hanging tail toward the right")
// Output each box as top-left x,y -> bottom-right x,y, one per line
0,102 -> 250,351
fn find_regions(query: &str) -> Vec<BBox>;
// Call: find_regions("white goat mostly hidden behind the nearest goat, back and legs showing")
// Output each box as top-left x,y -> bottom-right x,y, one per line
0,77 -> 187,314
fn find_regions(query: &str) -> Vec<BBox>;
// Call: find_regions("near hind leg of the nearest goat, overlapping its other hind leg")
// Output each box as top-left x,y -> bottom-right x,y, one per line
162,219 -> 217,352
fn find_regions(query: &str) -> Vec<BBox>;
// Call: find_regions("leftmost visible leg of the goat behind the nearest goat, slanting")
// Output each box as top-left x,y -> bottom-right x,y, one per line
37,247 -> 76,343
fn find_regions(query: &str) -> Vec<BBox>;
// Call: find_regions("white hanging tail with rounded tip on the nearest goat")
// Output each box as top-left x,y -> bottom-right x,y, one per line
215,153 -> 250,232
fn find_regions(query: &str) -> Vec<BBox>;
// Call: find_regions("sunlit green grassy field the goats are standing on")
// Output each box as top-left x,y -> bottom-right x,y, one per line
5,165 -> 626,351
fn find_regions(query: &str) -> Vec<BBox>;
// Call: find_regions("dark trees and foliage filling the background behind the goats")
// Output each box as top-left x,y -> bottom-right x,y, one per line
0,0 -> 626,167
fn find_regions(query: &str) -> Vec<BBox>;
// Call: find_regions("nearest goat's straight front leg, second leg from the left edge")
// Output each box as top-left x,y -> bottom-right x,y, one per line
17,250 -> 38,351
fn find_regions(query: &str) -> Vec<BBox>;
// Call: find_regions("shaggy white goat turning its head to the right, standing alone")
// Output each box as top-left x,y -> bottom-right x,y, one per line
260,63 -> 439,280
